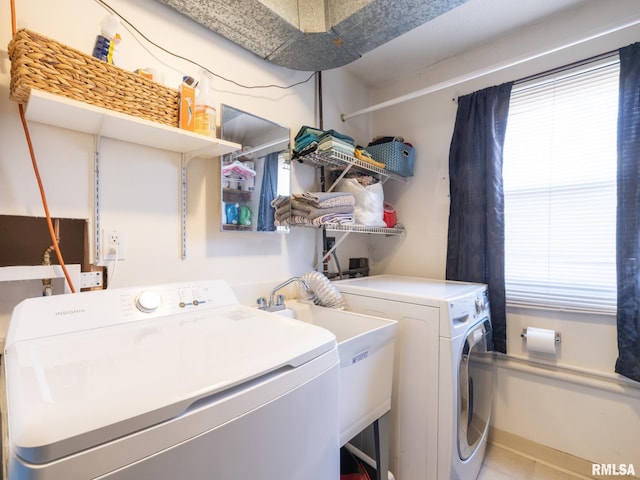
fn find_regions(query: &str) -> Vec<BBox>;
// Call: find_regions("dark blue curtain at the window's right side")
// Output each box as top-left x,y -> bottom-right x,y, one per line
615,43 -> 640,382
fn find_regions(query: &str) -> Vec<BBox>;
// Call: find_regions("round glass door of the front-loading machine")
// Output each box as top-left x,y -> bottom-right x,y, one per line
458,318 -> 495,460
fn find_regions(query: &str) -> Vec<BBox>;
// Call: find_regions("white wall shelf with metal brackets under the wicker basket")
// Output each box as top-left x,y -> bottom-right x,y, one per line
25,89 -> 242,264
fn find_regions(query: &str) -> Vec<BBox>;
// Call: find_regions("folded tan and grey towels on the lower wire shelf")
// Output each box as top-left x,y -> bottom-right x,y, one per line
271,192 -> 356,226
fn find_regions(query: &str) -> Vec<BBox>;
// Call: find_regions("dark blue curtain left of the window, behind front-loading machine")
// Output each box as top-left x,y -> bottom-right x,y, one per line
446,82 -> 513,353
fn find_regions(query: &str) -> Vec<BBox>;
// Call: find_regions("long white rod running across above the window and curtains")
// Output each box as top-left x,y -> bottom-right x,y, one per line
340,18 -> 640,122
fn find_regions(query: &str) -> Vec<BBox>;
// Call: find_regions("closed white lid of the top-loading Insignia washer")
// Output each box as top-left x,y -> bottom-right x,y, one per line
5,305 -> 336,464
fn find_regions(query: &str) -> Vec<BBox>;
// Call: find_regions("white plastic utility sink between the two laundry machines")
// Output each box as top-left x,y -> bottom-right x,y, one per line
287,300 -> 397,446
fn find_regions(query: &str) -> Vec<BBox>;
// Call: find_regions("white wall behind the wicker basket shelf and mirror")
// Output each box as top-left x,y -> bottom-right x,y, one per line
0,0 -> 369,316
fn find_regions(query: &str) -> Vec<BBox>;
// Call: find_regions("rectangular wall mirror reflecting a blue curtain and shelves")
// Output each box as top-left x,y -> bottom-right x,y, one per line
220,105 -> 291,233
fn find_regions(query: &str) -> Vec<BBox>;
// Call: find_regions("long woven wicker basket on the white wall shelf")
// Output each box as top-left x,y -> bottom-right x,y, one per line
9,30 -> 178,127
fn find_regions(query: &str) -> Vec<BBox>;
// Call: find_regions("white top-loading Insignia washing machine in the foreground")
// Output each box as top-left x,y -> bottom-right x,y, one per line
3,281 -> 340,480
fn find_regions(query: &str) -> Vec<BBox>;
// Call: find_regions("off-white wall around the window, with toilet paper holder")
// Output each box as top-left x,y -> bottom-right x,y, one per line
364,0 -> 640,468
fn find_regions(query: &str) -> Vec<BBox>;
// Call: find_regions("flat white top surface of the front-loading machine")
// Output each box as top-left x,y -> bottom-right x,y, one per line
334,275 -> 485,306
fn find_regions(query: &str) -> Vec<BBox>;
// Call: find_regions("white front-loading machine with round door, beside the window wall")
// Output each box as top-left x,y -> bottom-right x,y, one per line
334,275 -> 495,480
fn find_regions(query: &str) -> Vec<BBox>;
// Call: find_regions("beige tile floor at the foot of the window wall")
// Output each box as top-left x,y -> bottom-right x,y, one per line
478,443 -> 592,480
